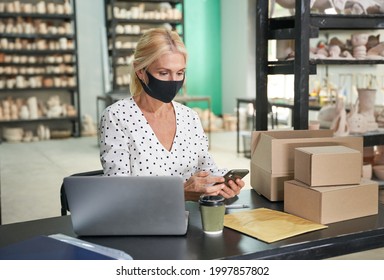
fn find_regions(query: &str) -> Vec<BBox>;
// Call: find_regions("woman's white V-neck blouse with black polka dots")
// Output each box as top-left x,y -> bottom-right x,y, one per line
100,97 -> 227,181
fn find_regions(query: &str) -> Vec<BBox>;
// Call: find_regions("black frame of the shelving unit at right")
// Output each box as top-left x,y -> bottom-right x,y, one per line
255,0 -> 384,146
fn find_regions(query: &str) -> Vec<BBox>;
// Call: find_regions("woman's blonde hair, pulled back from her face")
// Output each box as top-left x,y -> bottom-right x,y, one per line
129,28 -> 187,96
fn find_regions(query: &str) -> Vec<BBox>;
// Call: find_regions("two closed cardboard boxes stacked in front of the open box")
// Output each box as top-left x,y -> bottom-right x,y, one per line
284,146 -> 379,224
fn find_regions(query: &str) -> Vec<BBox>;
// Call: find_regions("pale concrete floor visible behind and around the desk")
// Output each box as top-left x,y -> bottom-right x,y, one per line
0,132 -> 384,260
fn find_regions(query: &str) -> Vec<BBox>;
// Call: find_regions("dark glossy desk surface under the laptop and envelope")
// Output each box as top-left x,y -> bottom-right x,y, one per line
0,190 -> 384,260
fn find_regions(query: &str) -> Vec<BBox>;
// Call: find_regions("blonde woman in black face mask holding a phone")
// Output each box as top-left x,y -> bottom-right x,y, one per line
100,29 -> 244,200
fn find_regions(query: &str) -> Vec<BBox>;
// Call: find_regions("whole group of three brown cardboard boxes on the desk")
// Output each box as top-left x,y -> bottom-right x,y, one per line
251,130 -> 378,223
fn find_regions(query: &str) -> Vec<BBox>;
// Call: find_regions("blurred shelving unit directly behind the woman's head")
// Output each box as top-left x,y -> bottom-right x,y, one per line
105,0 -> 184,93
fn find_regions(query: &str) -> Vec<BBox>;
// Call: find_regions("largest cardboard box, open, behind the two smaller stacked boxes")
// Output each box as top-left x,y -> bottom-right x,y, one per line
250,130 -> 363,201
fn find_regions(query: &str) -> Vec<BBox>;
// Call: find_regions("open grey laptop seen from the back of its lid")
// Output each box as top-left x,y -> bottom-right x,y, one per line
64,176 -> 188,236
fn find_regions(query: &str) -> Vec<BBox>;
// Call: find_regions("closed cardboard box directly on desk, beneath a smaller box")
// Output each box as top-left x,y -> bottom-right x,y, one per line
284,179 -> 379,224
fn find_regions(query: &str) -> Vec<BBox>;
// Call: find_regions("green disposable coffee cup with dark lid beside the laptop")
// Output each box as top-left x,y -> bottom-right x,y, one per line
199,195 -> 225,234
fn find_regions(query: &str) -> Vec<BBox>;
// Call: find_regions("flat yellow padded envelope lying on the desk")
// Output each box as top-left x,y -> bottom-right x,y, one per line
224,208 -> 327,243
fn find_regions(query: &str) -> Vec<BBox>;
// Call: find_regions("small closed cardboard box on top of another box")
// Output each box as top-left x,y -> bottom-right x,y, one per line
294,146 -> 362,187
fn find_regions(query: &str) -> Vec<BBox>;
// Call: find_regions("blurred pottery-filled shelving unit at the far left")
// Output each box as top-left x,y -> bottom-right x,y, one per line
0,0 -> 81,140
